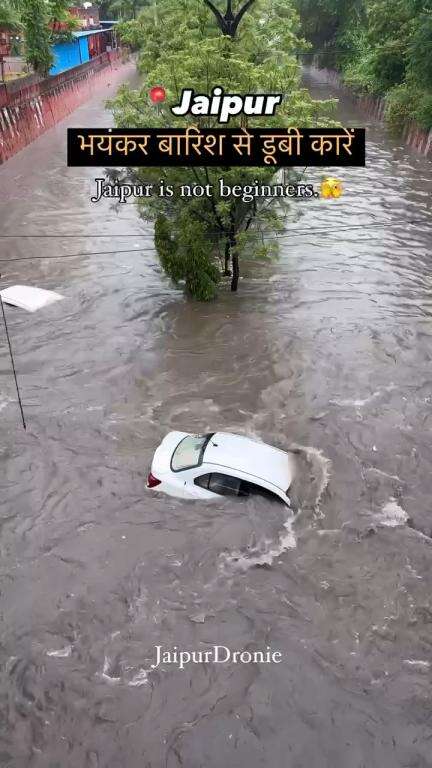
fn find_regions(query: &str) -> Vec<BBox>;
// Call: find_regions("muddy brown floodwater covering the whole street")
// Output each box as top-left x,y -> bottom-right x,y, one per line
0,67 -> 432,768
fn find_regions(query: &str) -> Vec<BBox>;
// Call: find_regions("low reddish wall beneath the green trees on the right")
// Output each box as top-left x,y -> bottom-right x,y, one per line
311,66 -> 432,159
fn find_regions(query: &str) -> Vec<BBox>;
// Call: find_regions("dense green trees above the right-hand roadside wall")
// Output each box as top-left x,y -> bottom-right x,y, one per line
296,0 -> 432,129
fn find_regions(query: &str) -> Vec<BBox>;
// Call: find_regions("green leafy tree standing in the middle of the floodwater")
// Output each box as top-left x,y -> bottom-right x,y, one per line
114,0 -> 329,300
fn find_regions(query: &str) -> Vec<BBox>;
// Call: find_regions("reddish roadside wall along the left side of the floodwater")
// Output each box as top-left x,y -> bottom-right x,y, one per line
0,49 -> 130,164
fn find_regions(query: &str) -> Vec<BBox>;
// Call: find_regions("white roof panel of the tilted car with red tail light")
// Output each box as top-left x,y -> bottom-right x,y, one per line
203,432 -> 293,493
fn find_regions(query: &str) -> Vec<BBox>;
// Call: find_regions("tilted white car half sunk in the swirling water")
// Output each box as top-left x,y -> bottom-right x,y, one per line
147,432 -> 294,505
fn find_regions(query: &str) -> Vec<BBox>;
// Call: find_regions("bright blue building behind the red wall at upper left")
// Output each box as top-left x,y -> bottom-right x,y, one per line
50,27 -> 114,75
